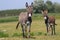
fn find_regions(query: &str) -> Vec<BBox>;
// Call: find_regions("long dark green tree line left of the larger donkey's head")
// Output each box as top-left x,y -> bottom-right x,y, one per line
0,9 -> 26,17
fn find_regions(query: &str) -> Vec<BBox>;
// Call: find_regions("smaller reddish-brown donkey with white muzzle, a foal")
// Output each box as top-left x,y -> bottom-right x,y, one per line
41,9 -> 56,35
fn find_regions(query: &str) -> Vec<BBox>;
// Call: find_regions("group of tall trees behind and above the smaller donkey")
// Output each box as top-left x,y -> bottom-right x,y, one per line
34,0 -> 60,13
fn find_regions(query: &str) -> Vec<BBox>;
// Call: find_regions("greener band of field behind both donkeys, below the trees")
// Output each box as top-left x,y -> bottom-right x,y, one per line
0,13 -> 60,23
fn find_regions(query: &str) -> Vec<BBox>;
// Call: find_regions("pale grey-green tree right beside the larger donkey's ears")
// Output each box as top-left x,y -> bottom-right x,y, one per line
34,0 -> 44,13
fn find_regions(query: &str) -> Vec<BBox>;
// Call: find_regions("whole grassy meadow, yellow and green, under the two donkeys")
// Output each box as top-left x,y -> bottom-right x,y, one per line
0,13 -> 60,40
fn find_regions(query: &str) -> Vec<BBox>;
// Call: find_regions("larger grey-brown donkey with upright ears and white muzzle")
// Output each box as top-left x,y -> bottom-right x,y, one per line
16,2 -> 33,37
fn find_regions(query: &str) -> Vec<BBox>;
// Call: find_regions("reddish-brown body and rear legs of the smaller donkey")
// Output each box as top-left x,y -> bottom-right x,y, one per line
48,16 -> 57,35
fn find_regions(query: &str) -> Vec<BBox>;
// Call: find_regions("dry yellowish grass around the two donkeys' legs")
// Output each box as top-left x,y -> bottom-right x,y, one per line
0,19 -> 60,40
